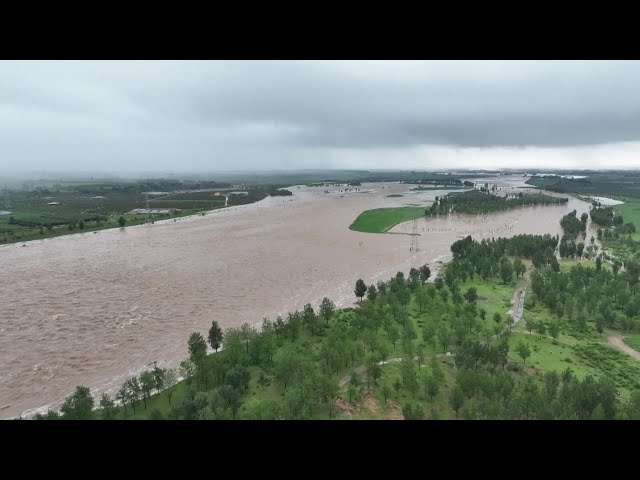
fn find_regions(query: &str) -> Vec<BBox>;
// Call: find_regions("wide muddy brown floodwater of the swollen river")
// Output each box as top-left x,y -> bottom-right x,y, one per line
0,177 -> 589,418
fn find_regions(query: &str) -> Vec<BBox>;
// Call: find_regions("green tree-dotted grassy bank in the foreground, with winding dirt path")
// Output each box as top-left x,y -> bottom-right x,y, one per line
38,235 -> 640,419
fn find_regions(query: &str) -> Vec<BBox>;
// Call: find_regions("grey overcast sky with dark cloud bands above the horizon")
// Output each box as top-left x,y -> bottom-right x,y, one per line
0,61 -> 640,175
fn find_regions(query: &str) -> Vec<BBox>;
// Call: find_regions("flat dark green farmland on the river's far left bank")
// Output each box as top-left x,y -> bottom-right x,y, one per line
0,180 -> 292,244
